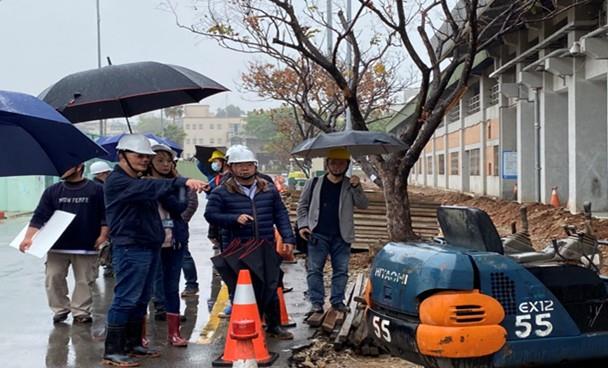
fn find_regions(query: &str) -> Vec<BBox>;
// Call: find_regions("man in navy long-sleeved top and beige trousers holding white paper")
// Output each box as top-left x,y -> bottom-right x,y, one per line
19,164 -> 108,323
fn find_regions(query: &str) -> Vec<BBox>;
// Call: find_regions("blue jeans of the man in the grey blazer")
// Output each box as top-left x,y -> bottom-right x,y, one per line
306,233 -> 350,305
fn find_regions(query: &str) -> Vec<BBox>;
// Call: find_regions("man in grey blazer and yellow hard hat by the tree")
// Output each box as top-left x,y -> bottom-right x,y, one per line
297,148 -> 368,314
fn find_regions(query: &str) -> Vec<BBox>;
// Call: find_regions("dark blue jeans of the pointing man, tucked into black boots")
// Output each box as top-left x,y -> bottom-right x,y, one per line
108,245 -> 160,326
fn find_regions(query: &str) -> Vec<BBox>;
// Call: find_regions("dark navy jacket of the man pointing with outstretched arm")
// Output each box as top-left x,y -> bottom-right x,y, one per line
104,165 -> 187,247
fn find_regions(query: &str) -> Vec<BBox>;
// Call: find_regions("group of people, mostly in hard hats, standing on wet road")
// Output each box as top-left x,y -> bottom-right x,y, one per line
20,134 -> 367,367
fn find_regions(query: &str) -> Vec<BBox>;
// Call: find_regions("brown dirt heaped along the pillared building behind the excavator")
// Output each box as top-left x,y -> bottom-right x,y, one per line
409,186 -> 608,274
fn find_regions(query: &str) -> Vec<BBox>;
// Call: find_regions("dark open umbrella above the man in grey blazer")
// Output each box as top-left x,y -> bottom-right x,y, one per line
291,130 -> 408,158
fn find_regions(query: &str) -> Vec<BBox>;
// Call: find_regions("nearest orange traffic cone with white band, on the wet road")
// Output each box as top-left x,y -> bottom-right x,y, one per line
212,270 -> 279,367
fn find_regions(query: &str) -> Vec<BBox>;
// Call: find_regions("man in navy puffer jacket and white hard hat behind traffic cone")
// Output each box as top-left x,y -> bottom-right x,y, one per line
205,147 -> 295,340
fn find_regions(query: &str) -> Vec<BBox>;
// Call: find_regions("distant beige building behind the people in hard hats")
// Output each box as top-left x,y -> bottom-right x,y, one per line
182,104 -> 246,158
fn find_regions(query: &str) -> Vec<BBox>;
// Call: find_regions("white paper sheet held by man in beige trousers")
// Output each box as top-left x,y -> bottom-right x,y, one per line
10,210 -> 76,258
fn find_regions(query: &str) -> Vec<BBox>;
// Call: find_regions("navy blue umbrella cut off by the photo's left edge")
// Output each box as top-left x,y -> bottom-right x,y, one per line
0,91 -> 107,176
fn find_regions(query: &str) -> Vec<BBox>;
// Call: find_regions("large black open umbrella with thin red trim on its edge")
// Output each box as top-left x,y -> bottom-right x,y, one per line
38,61 -> 228,129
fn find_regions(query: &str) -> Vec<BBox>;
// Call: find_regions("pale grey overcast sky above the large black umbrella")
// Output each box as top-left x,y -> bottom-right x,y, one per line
0,0 -> 276,111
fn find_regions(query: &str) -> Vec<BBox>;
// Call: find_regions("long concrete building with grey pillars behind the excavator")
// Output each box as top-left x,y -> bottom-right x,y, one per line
388,0 -> 608,212
